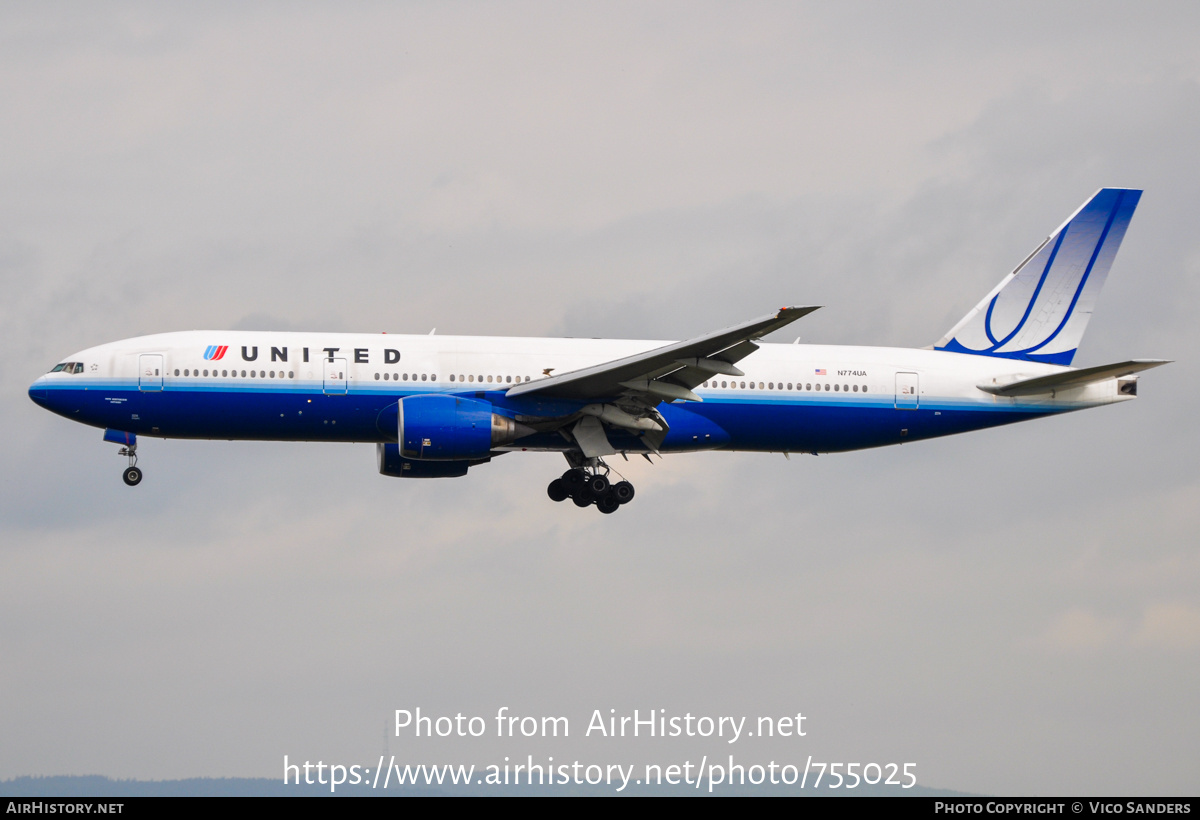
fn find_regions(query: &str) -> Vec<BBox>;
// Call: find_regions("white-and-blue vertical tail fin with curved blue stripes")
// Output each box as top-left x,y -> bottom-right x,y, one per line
934,188 -> 1141,365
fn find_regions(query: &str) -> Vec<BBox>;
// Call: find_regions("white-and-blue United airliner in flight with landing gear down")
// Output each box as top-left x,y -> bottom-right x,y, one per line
29,188 -> 1168,514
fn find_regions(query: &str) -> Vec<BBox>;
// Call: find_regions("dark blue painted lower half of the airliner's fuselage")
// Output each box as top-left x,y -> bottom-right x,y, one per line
30,383 -> 1060,453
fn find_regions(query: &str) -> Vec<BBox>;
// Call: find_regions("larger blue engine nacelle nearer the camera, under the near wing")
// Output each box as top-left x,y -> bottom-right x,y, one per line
396,395 -> 533,461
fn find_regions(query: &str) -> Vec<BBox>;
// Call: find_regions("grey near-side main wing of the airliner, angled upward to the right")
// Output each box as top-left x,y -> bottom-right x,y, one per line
506,306 -> 820,407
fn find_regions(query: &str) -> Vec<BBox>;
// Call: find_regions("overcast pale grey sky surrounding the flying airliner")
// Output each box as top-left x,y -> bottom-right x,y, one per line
0,4 -> 1200,794
